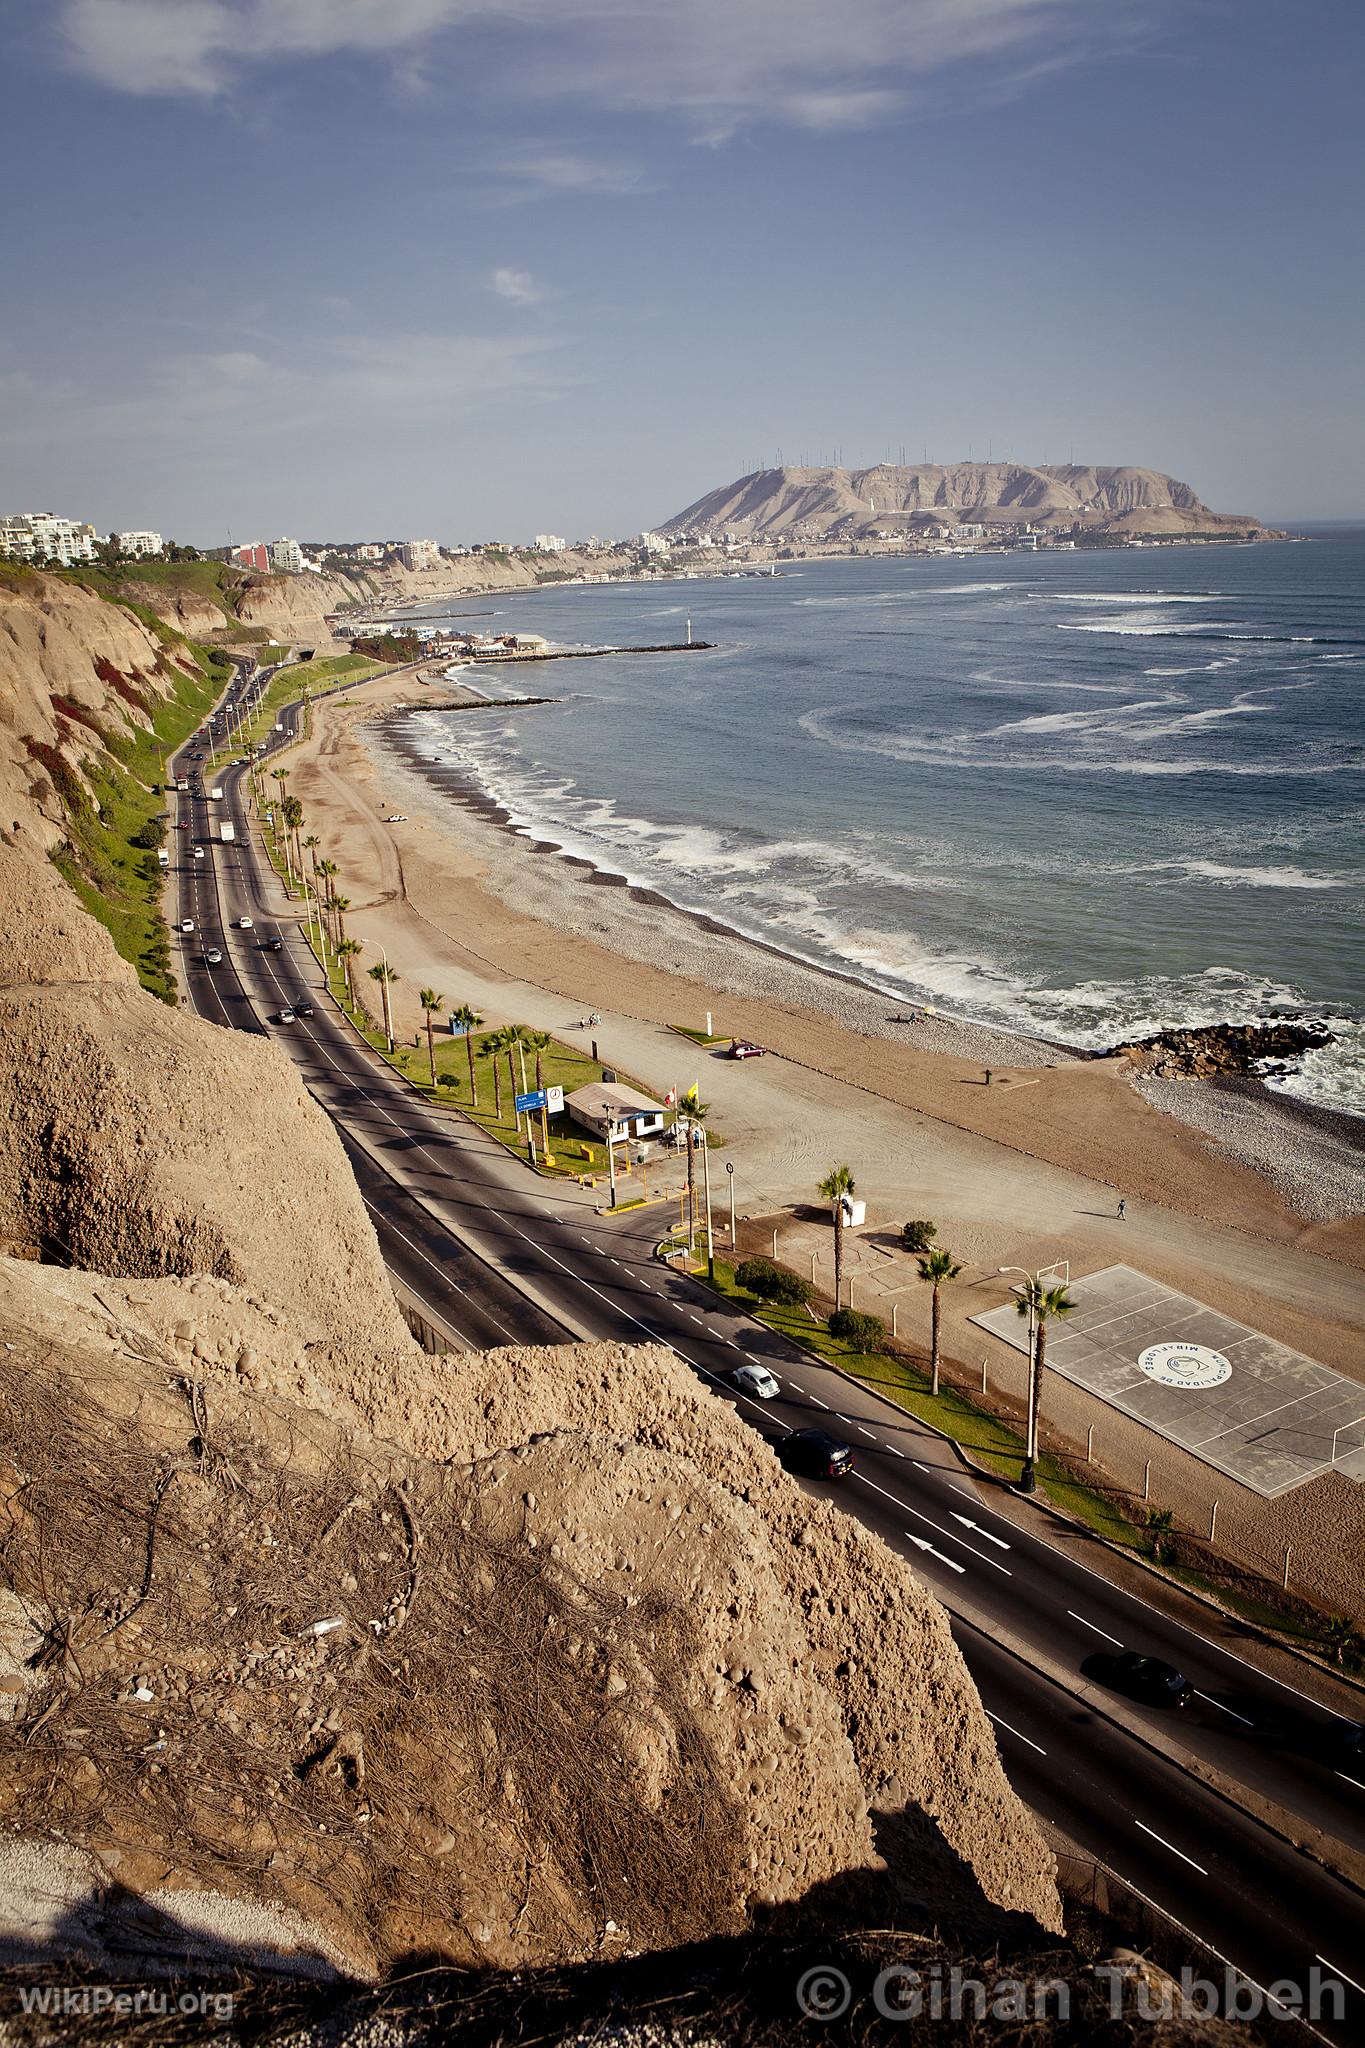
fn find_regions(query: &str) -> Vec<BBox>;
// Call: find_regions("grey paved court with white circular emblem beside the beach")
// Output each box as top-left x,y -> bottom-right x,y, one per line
972,1266 -> 1365,1497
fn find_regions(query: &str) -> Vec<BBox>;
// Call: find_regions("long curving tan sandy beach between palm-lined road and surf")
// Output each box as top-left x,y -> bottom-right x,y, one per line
280,676 -> 1365,1372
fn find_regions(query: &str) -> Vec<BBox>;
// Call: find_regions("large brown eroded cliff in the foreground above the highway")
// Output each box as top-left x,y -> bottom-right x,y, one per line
0,786 -> 1058,1970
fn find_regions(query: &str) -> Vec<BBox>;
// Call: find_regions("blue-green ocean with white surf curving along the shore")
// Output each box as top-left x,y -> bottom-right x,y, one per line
388,528 -> 1365,1112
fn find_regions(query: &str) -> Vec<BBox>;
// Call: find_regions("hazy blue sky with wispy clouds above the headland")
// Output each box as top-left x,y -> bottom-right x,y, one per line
0,0 -> 1365,547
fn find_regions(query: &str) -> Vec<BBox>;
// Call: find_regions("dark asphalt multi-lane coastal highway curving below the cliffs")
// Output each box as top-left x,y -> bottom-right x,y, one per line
170,676 -> 1365,2042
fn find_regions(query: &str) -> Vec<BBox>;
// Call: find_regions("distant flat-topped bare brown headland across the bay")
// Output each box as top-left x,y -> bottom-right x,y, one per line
659,463 -> 1263,543
